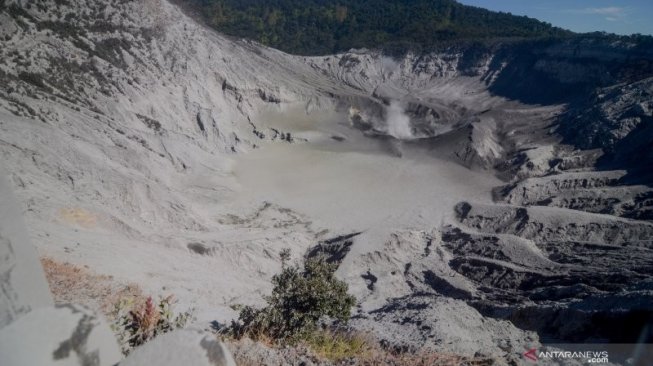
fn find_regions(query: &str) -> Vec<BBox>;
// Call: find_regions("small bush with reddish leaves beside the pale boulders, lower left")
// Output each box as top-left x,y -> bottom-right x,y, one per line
112,296 -> 193,355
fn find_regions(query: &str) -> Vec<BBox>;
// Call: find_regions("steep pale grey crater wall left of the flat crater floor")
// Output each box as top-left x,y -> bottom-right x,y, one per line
1,1 -> 346,314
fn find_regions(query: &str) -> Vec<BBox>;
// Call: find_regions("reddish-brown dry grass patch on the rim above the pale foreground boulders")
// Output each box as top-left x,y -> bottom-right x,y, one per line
41,257 -> 145,319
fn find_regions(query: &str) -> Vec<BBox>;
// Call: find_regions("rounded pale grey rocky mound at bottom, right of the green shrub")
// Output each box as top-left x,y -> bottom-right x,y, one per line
352,295 -> 539,365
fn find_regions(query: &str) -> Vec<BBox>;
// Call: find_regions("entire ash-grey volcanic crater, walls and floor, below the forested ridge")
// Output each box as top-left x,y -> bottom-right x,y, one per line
0,0 -> 653,359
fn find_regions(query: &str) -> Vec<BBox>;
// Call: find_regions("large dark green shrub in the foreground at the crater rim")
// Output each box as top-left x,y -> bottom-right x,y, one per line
227,251 -> 356,343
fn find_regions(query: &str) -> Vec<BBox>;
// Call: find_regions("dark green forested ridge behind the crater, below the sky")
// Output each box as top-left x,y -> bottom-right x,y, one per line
184,0 -> 571,55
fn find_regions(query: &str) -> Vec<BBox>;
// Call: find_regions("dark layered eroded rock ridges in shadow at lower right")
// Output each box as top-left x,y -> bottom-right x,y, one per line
443,203 -> 653,341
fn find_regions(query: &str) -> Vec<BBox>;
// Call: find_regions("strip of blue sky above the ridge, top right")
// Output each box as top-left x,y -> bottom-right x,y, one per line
458,0 -> 653,35
